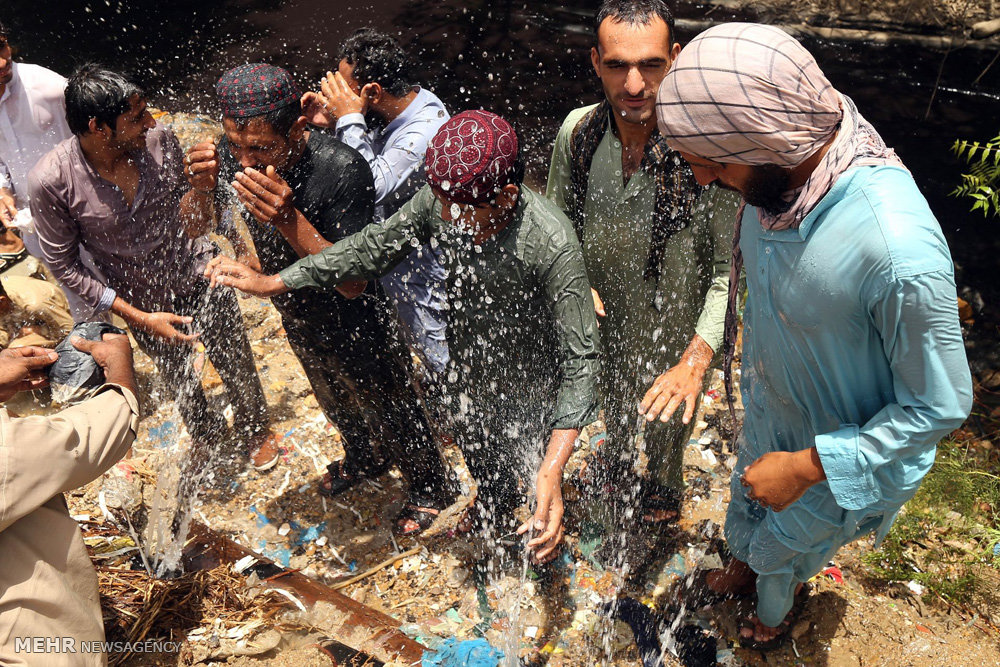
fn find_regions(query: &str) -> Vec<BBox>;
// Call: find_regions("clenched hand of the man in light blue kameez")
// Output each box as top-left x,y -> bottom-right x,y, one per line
740,447 -> 826,512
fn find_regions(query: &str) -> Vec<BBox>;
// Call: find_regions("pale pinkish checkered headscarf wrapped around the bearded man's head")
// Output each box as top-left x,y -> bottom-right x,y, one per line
656,23 -> 903,422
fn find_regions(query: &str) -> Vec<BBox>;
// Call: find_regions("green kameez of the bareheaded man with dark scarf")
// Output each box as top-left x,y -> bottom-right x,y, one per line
547,107 -> 737,488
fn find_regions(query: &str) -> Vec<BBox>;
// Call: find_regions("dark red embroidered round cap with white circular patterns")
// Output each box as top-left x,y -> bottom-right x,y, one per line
426,111 -> 518,204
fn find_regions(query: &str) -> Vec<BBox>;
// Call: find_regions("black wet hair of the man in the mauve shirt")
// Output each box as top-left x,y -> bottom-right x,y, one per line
66,64 -> 146,136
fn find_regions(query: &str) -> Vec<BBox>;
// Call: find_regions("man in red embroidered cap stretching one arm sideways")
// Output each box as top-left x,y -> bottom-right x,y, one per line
206,111 -> 600,562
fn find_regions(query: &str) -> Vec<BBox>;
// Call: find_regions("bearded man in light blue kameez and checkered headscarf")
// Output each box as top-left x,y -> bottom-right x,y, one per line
657,23 -> 972,648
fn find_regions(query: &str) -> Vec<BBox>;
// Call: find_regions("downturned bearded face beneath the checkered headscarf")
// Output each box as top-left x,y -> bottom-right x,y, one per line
681,152 -> 792,214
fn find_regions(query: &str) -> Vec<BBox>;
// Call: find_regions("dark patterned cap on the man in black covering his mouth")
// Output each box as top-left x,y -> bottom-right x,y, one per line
215,63 -> 302,118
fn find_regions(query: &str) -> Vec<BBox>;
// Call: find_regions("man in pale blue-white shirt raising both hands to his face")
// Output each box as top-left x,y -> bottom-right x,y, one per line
303,28 -> 450,374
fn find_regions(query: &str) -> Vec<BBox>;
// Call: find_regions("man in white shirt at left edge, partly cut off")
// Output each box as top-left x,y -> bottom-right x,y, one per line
0,22 -> 99,321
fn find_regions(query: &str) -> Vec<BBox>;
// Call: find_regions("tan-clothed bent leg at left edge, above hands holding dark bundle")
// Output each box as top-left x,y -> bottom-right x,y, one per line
0,276 -> 73,347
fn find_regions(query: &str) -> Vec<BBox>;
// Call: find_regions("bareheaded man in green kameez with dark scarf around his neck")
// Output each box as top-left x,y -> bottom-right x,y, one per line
547,0 -> 738,525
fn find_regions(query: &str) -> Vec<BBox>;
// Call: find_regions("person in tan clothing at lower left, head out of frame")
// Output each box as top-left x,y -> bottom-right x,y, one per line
0,334 -> 139,667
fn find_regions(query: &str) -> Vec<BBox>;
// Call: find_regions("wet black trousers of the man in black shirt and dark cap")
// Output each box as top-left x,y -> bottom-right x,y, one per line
283,317 -> 455,502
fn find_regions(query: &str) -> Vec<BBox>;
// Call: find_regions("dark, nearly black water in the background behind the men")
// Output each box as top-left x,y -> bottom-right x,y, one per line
2,0 -> 1000,310
